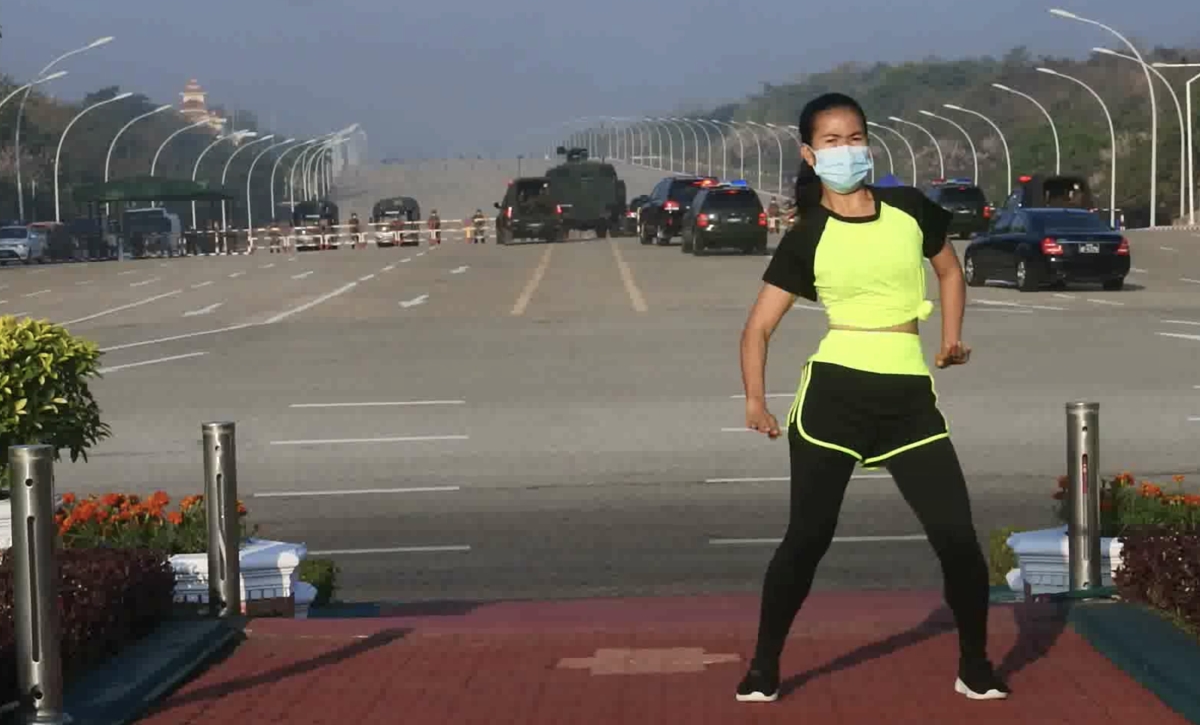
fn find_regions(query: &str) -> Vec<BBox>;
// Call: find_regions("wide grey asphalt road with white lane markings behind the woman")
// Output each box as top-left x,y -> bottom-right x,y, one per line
11,162 -> 1200,601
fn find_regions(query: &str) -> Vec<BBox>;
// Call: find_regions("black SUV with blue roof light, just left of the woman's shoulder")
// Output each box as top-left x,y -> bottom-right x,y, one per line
682,184 -> 767,257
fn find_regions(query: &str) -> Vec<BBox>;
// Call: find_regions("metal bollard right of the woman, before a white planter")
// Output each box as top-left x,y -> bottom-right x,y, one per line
1067,402 -> 1104,592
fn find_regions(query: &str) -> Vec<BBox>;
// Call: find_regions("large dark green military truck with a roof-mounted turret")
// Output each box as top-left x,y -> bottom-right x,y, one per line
546,146 -> 625,239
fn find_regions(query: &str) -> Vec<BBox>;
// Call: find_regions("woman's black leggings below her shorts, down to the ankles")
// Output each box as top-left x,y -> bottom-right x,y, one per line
755,424 -> 989,671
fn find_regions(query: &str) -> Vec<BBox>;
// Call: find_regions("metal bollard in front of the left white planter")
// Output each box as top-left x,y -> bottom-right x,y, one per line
200,423 -> 241,617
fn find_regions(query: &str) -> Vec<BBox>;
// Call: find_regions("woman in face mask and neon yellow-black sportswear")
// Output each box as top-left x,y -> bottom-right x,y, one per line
737,94 -> 1010,702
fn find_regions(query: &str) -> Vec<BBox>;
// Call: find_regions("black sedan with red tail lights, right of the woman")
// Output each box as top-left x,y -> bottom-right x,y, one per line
962,209 -> 1129,292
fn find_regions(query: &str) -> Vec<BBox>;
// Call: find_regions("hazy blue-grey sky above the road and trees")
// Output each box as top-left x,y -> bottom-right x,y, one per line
0,0 -> 1200,158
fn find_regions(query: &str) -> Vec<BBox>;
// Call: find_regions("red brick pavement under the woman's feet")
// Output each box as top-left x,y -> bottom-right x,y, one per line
143,592 -> 1187,725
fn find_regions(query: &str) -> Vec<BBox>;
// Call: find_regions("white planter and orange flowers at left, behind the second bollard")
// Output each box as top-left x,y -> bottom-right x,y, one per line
56,491 -> 334,616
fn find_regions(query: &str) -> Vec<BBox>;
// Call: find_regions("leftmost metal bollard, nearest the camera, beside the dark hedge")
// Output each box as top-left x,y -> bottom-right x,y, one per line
8,445 -> 67,725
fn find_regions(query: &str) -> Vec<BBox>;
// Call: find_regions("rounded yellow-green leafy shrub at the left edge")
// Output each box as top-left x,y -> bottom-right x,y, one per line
0,316 -> 112,489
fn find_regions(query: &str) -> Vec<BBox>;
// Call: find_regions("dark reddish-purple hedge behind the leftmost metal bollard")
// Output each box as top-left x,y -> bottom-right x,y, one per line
0,549 -> 175,702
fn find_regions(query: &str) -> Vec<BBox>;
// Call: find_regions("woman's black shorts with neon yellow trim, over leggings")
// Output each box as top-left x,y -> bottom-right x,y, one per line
788,361 -> 950,466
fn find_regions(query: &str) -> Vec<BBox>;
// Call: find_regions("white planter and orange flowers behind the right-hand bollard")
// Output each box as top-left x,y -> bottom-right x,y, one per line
992,473 -> 1200,604
